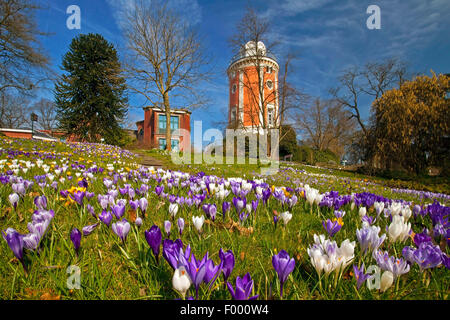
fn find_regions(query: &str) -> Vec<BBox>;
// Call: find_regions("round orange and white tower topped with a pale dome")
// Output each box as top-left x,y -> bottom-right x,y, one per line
227,41 -> 280,133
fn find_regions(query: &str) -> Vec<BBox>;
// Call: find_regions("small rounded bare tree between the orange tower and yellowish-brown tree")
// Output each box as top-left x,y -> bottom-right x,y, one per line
296,98 -> 356,156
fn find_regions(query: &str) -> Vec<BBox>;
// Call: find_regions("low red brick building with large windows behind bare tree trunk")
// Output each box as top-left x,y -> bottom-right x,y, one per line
136,106 -> 191,151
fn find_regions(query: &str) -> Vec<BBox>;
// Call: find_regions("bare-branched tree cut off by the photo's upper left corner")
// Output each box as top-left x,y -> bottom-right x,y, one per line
0,0 -> 50,93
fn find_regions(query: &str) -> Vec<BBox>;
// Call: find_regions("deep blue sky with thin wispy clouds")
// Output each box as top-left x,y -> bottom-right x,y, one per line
37,0 -> 450,139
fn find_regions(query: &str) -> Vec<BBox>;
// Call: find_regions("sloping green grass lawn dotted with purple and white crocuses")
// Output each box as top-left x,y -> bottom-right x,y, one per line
0,137 -> 450,300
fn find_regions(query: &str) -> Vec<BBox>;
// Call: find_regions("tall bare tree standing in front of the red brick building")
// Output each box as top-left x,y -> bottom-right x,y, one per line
125,1 -> 209,151
